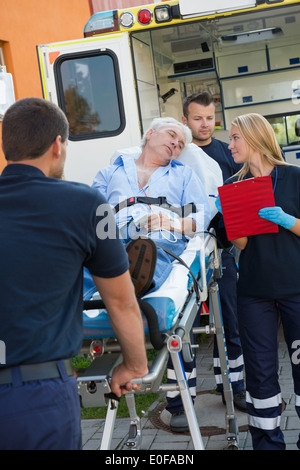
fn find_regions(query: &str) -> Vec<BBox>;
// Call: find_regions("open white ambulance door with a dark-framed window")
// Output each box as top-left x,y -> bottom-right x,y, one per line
37,33 -> 159,185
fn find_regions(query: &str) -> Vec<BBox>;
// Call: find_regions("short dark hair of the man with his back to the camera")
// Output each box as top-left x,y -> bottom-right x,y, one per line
2,98 -> 69,162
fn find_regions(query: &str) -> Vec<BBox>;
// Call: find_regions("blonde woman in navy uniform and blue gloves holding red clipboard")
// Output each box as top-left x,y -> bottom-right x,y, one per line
216,114 -> 300,450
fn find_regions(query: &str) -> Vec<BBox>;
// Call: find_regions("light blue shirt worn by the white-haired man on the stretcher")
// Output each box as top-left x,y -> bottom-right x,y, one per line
93,155 -> 211,232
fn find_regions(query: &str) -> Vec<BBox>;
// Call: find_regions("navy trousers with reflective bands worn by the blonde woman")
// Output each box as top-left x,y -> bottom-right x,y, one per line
238,295 -> 300,450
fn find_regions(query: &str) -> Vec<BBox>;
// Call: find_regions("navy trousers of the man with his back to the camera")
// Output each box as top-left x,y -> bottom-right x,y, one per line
0,361 -> 82,450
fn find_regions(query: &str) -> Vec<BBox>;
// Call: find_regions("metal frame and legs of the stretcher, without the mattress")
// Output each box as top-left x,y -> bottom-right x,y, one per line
77,231 -> 239,450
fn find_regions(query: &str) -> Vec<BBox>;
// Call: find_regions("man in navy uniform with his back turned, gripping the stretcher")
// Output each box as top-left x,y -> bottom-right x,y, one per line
0,98 -> 148,450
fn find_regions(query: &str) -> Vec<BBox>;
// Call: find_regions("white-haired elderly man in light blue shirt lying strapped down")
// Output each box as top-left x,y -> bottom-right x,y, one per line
85,118 -> 211,297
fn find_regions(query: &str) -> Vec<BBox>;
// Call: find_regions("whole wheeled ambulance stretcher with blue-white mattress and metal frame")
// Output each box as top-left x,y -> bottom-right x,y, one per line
77,231 -> 238,450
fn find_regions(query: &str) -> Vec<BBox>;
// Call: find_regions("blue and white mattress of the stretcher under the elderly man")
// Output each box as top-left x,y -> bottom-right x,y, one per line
83,237 -> 214,339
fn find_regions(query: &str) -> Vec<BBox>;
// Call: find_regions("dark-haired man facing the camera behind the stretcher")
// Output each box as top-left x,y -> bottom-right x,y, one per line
182,91 -> 246,412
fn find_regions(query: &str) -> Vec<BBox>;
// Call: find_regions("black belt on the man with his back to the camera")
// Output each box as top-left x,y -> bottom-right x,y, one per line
0,359 -> 73,385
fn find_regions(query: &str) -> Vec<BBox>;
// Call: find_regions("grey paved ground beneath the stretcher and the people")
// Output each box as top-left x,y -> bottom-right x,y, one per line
82,329 -> 300,455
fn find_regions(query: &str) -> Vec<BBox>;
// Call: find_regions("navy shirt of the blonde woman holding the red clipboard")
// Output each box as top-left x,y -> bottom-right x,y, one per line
226,165 -> 300,299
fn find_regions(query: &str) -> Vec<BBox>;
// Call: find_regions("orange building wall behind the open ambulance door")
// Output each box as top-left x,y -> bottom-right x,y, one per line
0,0 -> 93,172
